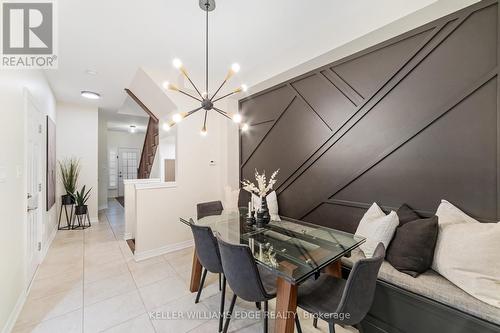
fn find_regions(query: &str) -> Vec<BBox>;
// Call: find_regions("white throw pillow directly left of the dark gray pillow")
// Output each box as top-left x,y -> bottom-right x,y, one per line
355,202 -> 399,258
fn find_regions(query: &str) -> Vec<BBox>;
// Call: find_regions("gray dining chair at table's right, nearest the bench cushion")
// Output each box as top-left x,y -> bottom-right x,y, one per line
295,243 -> 385,333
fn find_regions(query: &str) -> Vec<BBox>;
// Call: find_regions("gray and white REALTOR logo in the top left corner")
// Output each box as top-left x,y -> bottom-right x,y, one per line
1,0 -> 57,68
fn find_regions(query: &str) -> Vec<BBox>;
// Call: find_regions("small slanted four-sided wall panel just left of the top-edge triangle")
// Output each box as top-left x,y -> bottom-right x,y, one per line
292,74 -> 356,129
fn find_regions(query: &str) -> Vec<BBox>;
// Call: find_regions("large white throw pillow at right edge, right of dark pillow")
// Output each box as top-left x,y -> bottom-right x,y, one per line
432,200 -> 500,307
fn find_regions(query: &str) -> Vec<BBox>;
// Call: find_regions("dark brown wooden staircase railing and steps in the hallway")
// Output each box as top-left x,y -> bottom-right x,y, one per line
125,89 -> 160,179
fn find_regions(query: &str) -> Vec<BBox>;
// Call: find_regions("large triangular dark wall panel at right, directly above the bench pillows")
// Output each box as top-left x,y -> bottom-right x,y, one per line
334,80 -> 497,220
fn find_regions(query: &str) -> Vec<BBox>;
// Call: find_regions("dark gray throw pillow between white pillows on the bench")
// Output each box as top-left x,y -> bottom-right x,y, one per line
386,204 -> 438,277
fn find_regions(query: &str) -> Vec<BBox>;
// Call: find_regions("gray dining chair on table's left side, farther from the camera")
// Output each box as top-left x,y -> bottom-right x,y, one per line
189,220 -> 226,332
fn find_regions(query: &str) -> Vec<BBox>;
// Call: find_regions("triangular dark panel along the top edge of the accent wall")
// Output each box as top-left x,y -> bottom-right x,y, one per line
332,31 -> 430,97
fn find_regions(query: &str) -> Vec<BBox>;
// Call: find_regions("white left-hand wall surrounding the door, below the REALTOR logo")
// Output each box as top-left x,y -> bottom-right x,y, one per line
0,70 -> 57,332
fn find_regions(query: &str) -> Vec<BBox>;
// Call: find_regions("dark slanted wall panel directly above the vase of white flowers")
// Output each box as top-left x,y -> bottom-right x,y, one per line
242,98 -> 330,186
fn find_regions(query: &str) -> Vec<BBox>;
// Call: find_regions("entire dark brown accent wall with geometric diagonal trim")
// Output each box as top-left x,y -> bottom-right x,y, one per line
240,1 -> 500,232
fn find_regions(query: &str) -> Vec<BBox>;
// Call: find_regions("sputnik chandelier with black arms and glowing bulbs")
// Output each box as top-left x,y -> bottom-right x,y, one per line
163,0 -> 248,135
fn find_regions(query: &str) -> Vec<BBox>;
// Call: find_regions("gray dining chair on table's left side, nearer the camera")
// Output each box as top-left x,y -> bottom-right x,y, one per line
217,237 -> 276,333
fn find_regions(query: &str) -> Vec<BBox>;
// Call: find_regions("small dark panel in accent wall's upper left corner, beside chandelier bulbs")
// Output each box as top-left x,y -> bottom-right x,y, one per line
240,86 -> 295,124
